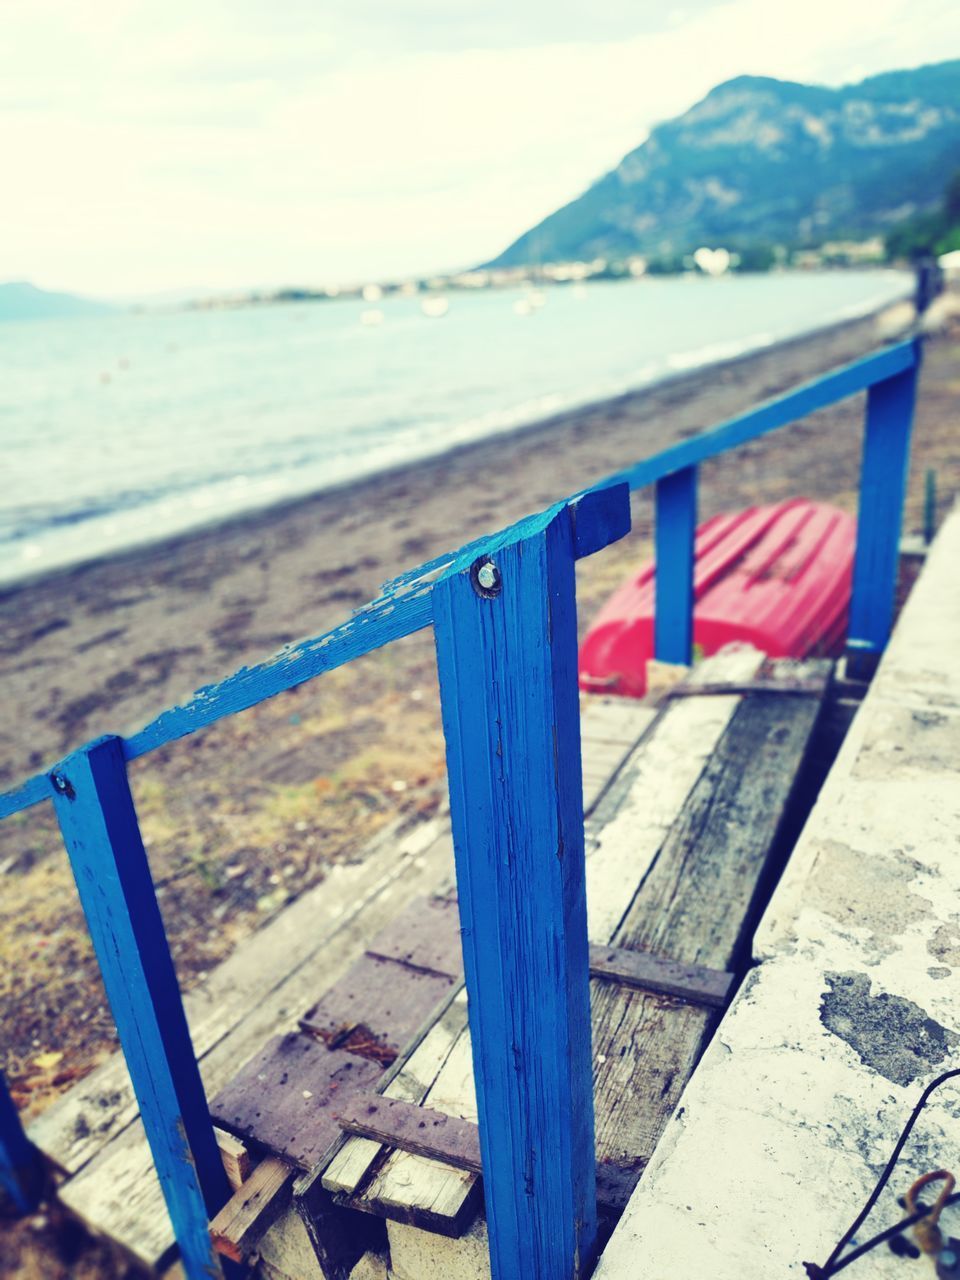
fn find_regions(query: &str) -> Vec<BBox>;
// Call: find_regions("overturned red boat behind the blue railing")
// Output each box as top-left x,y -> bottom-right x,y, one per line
580,498 -> 856,698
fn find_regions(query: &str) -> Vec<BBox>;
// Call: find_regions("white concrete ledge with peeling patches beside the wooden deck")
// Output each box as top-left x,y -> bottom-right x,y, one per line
596,512 -> 960,1280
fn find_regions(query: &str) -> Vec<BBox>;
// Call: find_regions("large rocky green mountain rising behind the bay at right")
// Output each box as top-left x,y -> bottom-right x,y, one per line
488,59 -> 960,266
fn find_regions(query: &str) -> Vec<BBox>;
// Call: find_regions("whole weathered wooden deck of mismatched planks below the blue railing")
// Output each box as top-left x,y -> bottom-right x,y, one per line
88,650 -> 829,1280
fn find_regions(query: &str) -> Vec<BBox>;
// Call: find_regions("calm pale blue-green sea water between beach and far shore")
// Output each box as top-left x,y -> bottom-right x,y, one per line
0,271 -> 910,581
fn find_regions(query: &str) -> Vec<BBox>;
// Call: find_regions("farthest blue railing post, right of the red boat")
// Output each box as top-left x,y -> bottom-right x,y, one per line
847,342 -> 920,676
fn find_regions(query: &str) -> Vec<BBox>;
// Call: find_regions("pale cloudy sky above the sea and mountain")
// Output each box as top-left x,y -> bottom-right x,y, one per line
0,0 -> 960,297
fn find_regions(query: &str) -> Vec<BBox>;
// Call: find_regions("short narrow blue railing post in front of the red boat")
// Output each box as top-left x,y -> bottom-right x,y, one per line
654,466 -> 696,667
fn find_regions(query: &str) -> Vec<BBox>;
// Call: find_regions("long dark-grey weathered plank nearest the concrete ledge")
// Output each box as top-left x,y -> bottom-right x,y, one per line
593,694 -> 819,1176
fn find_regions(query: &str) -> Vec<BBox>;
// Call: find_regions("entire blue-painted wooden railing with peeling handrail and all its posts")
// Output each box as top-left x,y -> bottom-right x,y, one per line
0,340 -> 920,1280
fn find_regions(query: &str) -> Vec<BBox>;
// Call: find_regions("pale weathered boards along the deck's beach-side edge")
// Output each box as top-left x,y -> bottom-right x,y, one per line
28,680 -> 657,1270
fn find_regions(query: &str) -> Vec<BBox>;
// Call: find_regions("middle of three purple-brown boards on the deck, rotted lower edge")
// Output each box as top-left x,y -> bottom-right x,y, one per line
300,957 -> 458,1066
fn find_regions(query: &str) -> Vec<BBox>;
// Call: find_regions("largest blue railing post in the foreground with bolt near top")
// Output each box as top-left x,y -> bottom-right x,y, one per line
434,485 -> 630,1280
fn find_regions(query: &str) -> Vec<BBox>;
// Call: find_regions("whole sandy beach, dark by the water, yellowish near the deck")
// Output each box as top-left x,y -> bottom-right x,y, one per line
0,304 -> 960,1275
